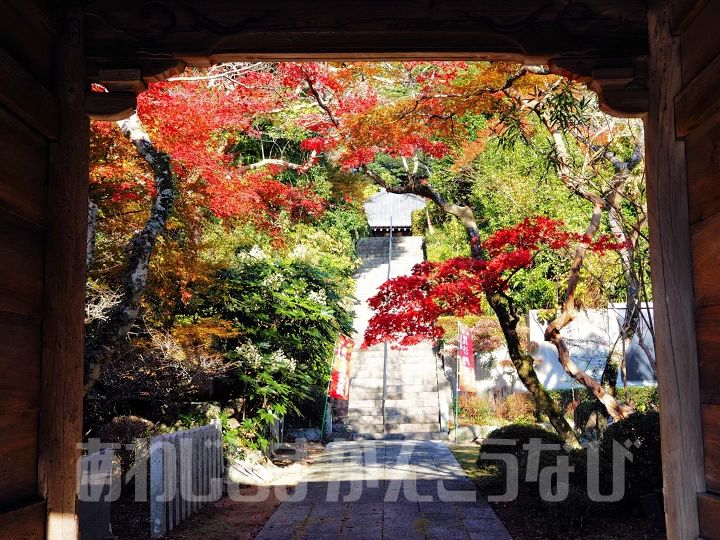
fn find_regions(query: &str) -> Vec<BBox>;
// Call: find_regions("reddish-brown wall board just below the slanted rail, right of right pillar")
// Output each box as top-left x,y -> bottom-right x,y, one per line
685,113 -> 720,224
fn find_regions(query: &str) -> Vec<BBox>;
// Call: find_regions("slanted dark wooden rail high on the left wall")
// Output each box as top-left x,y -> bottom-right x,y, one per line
0,49 -> 58,139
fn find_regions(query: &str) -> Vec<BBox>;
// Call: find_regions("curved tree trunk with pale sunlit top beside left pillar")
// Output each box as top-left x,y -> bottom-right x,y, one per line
84,114 -> 175,393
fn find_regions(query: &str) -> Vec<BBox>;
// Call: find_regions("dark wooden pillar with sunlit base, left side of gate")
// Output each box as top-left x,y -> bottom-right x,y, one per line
38,6 -> 89,540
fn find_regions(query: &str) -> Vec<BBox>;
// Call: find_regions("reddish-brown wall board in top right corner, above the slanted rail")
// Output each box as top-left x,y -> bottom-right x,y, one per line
681,0 -> 720,86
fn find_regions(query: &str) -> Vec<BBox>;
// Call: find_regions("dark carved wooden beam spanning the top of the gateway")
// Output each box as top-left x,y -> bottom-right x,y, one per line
85,0 -> 648,116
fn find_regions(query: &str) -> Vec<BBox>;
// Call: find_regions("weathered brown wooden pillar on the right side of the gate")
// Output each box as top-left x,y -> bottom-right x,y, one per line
646,0 -> 705,540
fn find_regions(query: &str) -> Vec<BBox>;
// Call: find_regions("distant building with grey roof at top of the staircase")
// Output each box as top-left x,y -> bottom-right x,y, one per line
365,189 -> 425,236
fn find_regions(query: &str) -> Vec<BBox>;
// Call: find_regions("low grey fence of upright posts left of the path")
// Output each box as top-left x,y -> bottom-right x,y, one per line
150,420 -> 224,538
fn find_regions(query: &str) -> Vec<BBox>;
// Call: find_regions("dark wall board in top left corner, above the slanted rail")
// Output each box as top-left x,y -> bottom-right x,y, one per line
0,0 -> 53,88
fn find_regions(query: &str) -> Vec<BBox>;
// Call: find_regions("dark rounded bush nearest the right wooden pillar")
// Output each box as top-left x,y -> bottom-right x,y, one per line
600,411 -> 662,503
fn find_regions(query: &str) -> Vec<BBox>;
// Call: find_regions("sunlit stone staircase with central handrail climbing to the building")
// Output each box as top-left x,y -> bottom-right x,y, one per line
333,237 -> 446,439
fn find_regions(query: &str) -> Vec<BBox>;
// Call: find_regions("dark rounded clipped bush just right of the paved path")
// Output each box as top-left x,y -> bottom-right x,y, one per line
477,424 -> 565,486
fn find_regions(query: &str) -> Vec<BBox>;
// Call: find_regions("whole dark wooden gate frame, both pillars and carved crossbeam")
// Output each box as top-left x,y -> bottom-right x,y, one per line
0,0 -> 720,540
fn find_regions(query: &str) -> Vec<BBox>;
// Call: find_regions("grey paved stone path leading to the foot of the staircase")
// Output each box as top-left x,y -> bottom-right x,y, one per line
256,440 -> 512,540
